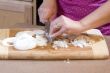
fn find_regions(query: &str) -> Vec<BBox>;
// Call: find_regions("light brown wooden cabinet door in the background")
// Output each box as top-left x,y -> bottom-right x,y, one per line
0,0 -> 33,27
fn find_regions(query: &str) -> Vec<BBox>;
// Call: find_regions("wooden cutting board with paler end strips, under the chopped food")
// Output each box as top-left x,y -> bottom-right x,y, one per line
0,28 -> 109,60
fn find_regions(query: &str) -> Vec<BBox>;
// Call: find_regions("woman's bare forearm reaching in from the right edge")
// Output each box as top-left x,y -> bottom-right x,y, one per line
80,0 -> 110,30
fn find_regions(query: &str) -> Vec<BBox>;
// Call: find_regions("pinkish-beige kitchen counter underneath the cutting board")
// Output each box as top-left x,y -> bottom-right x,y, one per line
0,27 -> 110,73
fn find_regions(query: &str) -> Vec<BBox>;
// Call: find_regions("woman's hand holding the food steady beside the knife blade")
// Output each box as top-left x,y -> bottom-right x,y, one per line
50,15 -> 84,37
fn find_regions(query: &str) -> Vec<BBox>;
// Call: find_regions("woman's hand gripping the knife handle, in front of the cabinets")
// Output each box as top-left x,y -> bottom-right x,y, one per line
38,0 -> 57,23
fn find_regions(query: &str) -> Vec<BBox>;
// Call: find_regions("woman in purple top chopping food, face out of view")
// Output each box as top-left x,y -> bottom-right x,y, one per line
38,0 -> 110,37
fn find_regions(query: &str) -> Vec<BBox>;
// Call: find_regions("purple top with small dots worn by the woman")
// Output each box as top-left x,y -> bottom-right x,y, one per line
57,0 -> 110,35
